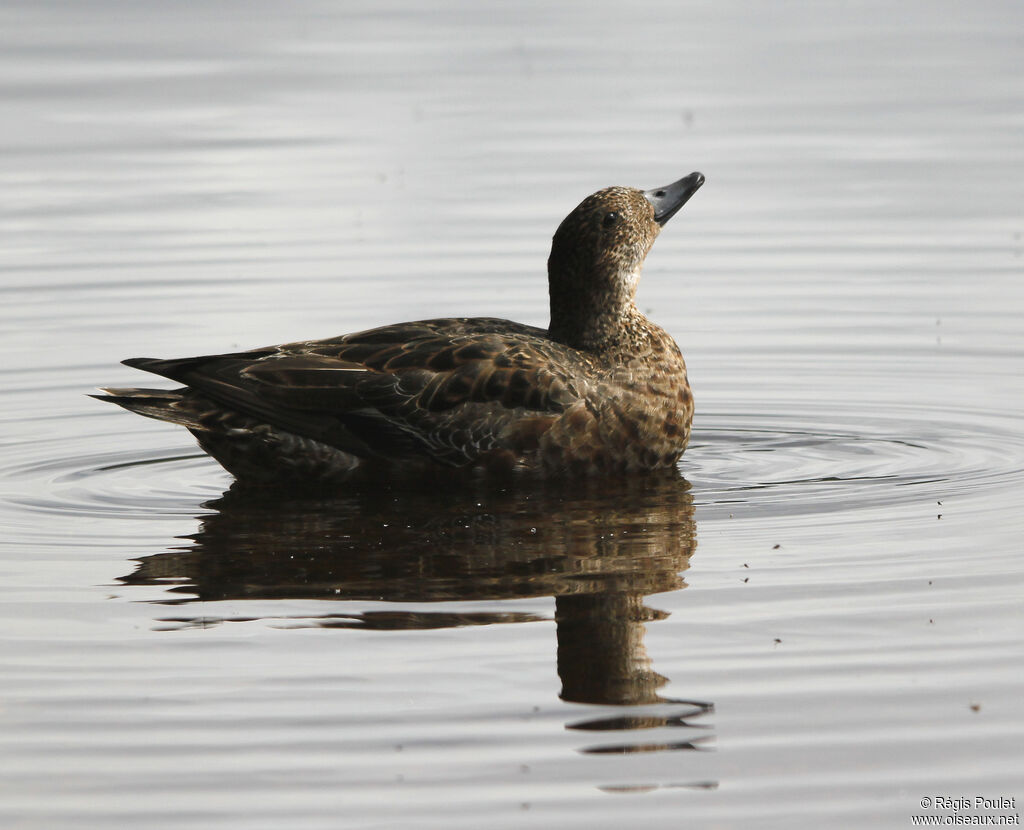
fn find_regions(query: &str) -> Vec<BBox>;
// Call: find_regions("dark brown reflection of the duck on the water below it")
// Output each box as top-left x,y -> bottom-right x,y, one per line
122,474 -> 710,751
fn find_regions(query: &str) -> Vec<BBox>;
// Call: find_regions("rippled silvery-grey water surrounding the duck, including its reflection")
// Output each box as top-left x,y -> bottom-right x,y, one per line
0,0 -> 1024,830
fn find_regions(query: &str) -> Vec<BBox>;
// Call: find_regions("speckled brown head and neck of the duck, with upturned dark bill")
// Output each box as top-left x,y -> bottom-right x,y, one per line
548,173 -> 705,348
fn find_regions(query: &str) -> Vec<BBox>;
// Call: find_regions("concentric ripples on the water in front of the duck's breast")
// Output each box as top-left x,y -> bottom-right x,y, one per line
684,407 -> 1024,516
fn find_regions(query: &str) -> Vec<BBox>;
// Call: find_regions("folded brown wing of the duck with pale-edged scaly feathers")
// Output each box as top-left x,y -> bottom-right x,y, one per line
125,320 -> 581,465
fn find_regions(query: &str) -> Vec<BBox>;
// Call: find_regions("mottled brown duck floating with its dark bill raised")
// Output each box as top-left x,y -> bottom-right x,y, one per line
93,172 -> 705,483
